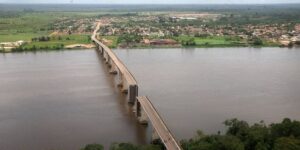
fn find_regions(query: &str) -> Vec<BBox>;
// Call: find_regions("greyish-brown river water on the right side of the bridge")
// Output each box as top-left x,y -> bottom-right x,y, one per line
115,48 -> 300,139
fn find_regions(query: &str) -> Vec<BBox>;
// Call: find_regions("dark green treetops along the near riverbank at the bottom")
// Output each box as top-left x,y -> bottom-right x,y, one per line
82,118 -> 300,150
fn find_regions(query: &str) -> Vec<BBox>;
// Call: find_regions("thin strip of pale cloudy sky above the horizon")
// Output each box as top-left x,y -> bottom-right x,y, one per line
0,0 -> 300,4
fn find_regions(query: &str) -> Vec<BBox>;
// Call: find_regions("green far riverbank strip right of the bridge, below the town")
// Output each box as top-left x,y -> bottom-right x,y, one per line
100,36 -> 281,49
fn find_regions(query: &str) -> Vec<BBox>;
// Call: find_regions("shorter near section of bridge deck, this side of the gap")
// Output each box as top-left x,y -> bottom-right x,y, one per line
137,96 -> 181,150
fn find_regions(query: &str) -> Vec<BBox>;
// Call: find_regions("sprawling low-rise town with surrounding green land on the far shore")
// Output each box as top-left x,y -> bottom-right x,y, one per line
0,4 -> 300,52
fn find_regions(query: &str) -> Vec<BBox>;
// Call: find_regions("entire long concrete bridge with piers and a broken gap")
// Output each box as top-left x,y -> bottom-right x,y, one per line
92,23 -> 182,150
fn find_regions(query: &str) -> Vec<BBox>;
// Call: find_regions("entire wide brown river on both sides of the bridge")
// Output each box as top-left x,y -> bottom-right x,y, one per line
0,48 -> 300,150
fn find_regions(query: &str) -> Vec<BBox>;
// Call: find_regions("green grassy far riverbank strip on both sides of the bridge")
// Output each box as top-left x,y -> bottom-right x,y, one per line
0,34 -> 292,53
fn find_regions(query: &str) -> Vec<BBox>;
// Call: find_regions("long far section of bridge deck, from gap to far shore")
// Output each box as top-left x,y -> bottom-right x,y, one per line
92,23 -> 137,85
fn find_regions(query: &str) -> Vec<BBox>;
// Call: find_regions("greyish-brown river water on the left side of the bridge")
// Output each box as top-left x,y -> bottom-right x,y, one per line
0,50 -> 146,150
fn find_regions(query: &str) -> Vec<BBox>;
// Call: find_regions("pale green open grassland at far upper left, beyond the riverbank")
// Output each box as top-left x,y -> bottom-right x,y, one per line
0,12 -> 96,42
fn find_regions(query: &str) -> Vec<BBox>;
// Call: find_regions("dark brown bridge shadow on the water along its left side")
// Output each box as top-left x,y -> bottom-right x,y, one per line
95,50 -> 150,144
